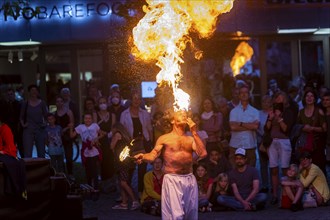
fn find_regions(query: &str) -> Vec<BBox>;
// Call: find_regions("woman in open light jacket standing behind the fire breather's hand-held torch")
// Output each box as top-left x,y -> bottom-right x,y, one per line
120,91 -> 153,193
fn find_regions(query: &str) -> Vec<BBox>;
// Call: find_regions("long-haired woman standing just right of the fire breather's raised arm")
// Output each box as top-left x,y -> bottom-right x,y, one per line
201,97 -> 223,153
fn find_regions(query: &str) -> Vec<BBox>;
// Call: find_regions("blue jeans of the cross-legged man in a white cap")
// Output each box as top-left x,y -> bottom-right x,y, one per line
217,193 -> 267,211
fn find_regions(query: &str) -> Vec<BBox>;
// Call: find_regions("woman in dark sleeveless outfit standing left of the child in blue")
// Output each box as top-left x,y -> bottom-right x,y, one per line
20,84 -> 48,158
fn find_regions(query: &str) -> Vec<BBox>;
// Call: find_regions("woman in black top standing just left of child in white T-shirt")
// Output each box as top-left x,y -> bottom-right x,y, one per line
54,96 -> 75,179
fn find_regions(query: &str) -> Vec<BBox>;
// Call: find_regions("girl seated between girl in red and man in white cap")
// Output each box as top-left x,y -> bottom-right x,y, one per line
208,173 -> 232,211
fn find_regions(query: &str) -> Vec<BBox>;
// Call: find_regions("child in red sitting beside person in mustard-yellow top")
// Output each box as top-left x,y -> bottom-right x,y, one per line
281,164 -> 304,212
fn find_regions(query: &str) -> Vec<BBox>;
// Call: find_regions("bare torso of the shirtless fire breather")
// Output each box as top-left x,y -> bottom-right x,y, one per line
159,133 -> 193,174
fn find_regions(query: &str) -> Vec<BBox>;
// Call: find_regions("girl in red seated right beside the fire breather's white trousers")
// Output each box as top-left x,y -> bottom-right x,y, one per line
195,163 -> 213,212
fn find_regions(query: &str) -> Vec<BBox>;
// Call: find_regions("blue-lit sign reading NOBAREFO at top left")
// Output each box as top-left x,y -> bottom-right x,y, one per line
0,2 -> 135,21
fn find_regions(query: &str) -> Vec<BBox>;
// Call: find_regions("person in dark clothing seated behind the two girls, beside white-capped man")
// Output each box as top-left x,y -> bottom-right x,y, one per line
206,148 -> 232,178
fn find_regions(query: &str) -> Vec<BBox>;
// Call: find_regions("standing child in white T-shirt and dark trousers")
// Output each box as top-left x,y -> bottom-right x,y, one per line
70,112 -> 105,190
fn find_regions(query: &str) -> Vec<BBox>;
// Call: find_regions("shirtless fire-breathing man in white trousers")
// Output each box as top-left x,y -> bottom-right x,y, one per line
135,111 -> 207,219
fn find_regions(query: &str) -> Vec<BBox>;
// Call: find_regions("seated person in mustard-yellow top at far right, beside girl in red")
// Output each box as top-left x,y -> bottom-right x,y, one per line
299,152 -> 330,206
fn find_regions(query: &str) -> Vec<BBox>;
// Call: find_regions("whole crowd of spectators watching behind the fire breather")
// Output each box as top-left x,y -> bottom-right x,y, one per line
2,74 -> 330,214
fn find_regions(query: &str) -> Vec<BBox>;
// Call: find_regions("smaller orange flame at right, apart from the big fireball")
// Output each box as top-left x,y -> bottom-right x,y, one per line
230,41 -> 253,76
